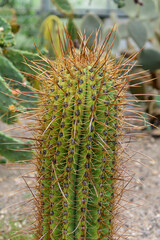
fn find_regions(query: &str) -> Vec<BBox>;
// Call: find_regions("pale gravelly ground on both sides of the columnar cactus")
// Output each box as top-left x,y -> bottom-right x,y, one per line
0,119 -> 160,240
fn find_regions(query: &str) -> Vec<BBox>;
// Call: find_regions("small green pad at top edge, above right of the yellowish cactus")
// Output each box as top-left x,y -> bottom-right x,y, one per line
51,0 -> 73,16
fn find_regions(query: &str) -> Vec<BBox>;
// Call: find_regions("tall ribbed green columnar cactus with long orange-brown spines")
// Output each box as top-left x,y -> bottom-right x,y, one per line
30,33 -> 137,240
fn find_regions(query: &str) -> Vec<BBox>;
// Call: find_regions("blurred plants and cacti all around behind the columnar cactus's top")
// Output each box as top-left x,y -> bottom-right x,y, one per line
0,0 -> 160,159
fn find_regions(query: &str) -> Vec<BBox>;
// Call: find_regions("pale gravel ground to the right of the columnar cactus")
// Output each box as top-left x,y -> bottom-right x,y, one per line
121,136 -> 160,240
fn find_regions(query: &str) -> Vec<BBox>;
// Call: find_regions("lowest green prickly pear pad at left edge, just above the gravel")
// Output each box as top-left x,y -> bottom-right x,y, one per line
0,132 -> 32,162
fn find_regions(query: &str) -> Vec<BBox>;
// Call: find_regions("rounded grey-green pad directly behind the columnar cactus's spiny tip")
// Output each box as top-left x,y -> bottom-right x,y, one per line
81,13 -> 102,47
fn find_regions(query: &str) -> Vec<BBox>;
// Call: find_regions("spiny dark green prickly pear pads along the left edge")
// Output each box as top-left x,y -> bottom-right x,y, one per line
0,17 -> 40,161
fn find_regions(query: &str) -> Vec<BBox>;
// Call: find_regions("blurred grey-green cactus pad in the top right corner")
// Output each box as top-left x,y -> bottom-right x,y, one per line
139,0 -> 157,20
